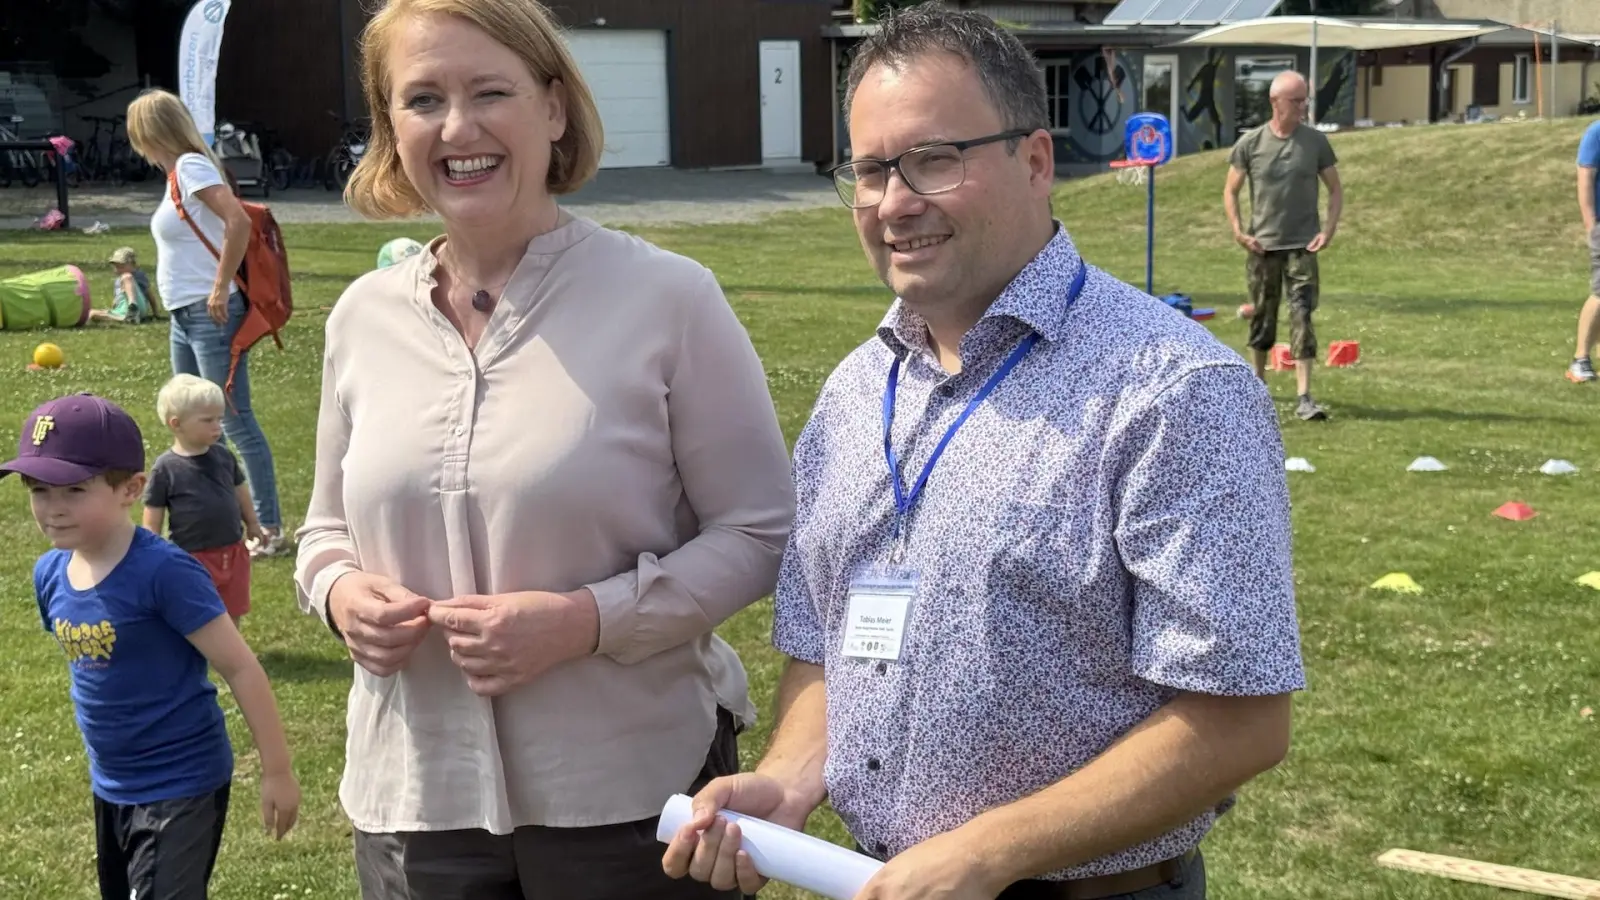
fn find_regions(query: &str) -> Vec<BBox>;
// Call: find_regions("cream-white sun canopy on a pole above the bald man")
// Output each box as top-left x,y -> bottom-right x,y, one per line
1178,16 -> 1510,123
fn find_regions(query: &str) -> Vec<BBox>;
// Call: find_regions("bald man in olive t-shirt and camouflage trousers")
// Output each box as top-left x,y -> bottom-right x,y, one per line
1222,72 -> 1344,421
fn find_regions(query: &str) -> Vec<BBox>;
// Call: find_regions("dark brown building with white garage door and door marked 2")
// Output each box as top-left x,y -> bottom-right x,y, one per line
218,0 -> 835,168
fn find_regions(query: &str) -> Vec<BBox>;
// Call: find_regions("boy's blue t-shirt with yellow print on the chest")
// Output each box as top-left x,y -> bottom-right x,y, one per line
34,528 -> 234,804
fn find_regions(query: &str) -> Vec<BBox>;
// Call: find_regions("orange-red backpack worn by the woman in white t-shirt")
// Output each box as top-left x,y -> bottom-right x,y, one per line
166,171 -> 294,392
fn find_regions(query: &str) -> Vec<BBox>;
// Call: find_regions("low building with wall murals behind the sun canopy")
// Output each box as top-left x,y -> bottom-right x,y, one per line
829,0 -> 1600,176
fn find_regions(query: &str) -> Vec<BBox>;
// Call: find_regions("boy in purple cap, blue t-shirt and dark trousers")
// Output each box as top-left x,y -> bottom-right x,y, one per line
0,394 -> 301,900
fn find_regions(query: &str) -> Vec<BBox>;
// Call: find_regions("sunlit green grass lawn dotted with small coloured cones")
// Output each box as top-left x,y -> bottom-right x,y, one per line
0,122 -> 1600,900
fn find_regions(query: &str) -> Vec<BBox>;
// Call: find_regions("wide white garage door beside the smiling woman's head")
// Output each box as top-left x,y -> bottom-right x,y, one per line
566,29 -> 672,168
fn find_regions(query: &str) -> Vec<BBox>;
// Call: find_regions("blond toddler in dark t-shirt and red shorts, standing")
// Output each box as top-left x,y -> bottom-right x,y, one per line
144,375 -> 264,628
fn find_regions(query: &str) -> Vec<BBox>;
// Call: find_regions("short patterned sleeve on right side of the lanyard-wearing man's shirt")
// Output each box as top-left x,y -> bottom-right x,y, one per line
1117,365 -> 1306,697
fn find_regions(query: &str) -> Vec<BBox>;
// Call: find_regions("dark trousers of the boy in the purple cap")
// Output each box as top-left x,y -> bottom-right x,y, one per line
94,775 -> 230,900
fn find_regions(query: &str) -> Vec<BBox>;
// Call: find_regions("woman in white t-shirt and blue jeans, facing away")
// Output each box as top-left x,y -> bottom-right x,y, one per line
128,90 -> 288,556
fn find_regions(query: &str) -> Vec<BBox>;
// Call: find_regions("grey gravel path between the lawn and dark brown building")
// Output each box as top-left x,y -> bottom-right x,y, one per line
0,170 -> 843,229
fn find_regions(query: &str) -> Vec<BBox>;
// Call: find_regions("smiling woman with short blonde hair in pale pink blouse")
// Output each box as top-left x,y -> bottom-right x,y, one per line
298,0 -> 794,900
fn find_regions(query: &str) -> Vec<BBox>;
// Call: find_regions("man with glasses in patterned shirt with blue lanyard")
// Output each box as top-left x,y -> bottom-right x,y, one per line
662,5 -> 1304,900
